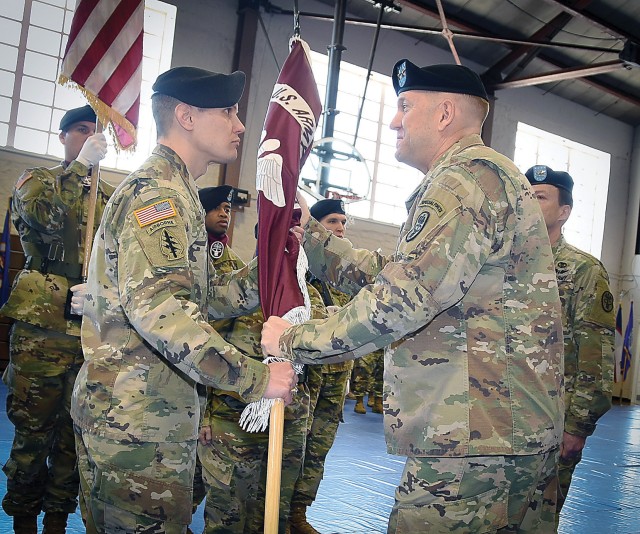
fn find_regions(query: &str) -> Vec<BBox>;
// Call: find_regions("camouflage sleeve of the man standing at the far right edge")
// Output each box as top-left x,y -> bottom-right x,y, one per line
565,263 -> 615,437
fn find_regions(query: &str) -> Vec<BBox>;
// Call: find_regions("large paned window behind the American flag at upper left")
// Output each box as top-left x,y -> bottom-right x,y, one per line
0,0 -> 176,171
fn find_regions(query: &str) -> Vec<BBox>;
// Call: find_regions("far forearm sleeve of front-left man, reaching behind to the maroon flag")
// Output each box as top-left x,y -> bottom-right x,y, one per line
209,258 -> 260,320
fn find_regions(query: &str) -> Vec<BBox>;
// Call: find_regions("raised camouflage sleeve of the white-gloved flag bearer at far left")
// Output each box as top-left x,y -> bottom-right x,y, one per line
12,161 -> 88,234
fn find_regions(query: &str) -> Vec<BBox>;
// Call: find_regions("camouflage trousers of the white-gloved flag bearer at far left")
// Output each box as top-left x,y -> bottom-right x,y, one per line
2,322 -> 82,516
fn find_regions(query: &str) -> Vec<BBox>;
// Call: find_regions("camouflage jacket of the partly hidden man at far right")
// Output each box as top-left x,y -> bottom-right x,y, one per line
553,237 -> 615,437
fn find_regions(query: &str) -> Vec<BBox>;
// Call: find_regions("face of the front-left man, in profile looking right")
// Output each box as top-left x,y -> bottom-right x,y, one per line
192,105 -> 244,164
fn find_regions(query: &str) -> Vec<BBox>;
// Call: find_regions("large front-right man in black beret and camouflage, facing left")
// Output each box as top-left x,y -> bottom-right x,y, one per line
262,60 -> 564,533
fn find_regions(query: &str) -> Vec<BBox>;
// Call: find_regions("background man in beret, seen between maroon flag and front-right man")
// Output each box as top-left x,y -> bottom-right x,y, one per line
290,199 -> 353,534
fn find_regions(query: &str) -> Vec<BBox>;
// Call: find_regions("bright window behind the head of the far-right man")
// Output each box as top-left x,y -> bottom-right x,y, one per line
514,122 -> 611,258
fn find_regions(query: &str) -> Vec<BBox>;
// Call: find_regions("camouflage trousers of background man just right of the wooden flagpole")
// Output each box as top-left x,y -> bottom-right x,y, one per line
291,365 -> 350,506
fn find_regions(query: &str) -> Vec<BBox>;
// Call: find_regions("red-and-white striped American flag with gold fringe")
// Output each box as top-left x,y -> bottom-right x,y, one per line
58,0 -> 144,149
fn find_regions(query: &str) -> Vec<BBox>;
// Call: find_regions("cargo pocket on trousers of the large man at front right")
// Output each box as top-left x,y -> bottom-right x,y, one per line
396,488 -> 508,534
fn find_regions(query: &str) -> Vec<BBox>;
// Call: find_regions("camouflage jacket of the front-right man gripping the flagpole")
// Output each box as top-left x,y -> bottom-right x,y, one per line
280,135 -> 564,456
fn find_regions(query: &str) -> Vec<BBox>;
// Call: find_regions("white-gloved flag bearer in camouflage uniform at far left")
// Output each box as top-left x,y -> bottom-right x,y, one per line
1,106 -> 113,533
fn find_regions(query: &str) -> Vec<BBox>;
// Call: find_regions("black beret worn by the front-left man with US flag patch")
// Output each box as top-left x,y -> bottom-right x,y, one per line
152,67 -> 245,108
